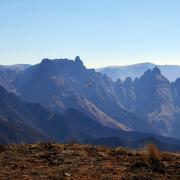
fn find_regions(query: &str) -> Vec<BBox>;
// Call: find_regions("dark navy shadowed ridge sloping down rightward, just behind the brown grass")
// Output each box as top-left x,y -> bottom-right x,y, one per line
0,86 -> 180,151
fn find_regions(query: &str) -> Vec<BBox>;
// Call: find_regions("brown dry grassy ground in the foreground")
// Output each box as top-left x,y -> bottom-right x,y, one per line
0,143 -> 180,179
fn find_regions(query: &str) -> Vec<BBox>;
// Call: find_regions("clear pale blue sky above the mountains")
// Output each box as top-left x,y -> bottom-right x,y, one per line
0,0 -> 180,67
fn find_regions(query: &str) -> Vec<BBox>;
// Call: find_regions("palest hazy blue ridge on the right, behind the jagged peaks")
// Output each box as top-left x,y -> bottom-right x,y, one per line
97,63 -> 180,81
